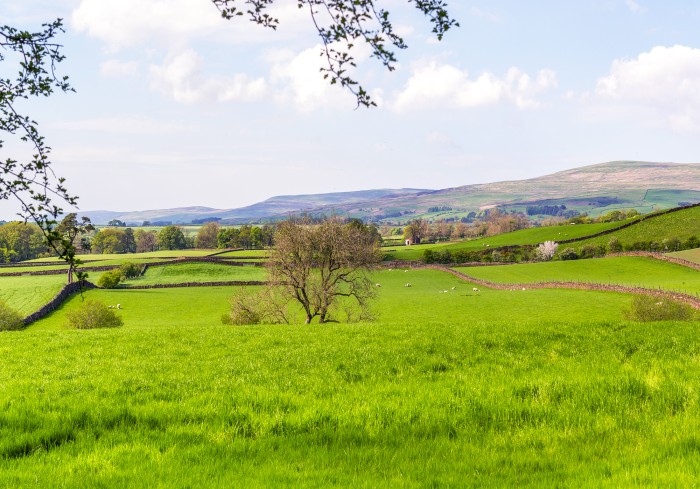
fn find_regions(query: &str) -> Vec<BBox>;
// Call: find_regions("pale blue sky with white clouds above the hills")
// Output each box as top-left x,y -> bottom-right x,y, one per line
0,0 -> 700,219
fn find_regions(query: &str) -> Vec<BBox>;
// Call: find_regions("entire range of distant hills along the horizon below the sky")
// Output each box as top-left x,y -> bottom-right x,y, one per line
81,161 -> 700,224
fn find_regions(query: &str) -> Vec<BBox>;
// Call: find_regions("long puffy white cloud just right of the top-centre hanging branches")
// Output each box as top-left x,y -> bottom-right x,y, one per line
391,62 -> 557,112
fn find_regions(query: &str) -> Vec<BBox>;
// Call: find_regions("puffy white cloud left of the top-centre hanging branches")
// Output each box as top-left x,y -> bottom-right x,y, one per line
149,49 -> 267,103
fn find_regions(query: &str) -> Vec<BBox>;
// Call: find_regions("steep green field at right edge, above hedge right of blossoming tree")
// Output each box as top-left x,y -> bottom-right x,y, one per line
572,207 -> 700,249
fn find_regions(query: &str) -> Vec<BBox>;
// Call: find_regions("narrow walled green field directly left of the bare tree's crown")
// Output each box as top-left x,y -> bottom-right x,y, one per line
124,263 -> 267,285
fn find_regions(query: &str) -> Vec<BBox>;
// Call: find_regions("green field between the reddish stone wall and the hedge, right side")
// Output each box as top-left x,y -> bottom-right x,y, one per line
455,256 -> 700,293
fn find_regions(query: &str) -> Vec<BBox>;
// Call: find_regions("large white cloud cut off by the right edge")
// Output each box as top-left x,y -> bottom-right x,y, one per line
596,45 -> 700,131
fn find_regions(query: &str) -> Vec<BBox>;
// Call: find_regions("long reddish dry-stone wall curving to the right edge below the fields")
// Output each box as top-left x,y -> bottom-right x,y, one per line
424,264 -> 700,310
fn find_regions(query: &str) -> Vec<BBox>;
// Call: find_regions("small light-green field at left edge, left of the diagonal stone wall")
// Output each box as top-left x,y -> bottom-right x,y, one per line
0,275 -> 67,316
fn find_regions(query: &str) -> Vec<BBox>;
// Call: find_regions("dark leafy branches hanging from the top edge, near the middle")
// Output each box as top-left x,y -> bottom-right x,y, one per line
211,0 -> 459,107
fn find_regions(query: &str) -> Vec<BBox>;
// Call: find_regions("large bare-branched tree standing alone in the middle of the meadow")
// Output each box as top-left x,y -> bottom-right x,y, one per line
268,218 -> 381,324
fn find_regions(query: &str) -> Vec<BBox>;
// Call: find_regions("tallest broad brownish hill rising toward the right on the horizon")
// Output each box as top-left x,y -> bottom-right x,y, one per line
330,161 -> 700,220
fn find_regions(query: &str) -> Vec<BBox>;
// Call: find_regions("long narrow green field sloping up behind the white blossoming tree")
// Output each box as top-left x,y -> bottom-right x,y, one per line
382,222 -> 624,260
